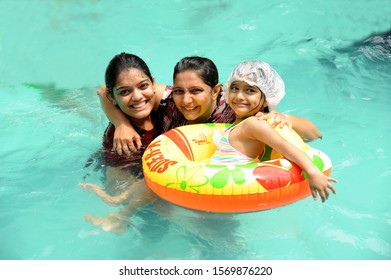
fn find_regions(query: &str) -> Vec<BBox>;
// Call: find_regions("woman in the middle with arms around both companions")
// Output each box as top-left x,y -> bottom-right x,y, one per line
98,56 -> 321,155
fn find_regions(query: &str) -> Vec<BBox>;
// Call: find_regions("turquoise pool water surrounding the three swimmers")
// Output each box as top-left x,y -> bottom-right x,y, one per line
0,0 -> 391,260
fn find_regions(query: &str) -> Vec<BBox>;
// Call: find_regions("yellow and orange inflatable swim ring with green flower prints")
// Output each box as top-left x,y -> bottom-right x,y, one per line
142,121 -> 331,212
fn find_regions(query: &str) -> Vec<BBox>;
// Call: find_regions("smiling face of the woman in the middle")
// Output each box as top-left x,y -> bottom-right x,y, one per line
173,70 -> 220,123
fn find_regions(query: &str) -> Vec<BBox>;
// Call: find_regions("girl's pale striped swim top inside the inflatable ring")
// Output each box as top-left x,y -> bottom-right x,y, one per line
209,120 -> 259,164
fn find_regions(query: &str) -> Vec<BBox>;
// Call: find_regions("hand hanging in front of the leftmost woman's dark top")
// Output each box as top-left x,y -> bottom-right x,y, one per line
112,123 -> 142,156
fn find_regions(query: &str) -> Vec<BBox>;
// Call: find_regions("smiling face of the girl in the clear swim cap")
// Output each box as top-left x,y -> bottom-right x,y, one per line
227,81 -> 267,118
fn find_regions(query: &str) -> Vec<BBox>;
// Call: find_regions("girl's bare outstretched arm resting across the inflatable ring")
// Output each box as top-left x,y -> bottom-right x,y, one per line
248,118 -> 336,202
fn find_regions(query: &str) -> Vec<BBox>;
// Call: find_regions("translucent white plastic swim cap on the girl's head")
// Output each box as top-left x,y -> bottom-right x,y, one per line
223,60 -> 285,111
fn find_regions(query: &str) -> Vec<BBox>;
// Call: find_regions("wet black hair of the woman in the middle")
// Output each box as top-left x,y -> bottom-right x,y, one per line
173,56 -> 219,88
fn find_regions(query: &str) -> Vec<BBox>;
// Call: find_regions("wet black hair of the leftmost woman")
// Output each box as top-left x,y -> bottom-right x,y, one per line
105,52 -> 152,96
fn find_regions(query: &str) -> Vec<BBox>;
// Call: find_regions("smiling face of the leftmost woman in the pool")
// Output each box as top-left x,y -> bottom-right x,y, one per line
113,68 -> 156,119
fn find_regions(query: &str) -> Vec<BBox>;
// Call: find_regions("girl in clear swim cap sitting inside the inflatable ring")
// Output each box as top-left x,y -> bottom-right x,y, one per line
211,60 -> 336,202
